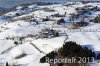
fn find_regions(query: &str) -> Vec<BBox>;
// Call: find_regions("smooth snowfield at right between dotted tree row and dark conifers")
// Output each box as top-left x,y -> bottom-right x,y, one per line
67,32 -> 100,51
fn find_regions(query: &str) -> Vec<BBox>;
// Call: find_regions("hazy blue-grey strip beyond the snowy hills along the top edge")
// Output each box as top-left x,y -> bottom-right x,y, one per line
0,0 -> 100,8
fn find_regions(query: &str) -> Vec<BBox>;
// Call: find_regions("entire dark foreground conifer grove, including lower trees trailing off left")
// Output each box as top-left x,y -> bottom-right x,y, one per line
40,41 -> 96,63
